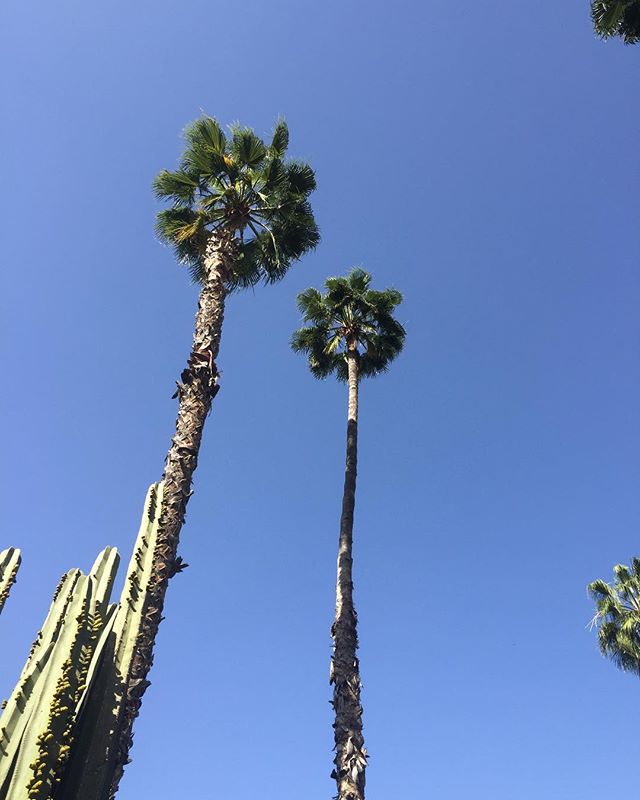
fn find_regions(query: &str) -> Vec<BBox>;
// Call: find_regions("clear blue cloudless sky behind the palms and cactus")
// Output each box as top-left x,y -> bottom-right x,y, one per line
0,0 -> 640,800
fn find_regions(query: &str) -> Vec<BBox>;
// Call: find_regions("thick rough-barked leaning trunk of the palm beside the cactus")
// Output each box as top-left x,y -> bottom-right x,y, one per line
110,228 -> 234,798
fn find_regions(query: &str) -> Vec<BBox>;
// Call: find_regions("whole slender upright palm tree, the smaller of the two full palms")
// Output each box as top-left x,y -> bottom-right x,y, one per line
292,269 -> 405,800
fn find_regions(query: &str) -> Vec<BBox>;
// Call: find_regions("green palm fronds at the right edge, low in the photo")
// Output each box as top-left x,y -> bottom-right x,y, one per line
588,558 -> 640,675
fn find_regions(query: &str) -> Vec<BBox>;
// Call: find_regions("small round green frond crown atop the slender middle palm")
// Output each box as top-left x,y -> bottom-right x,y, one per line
291,267 -> 406,381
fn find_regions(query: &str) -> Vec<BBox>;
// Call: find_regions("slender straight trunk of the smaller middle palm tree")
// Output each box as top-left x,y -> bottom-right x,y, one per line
330,345 -> 367,800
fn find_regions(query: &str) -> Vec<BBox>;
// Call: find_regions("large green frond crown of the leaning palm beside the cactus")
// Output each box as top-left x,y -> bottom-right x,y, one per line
153,115 -> 320,289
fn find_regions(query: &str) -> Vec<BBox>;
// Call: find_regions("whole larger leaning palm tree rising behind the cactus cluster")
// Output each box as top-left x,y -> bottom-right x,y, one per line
112,116 -> 320,795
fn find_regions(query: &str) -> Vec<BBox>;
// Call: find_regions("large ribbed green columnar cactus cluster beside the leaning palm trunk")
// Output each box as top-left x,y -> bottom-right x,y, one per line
0,483 -> 168,800
